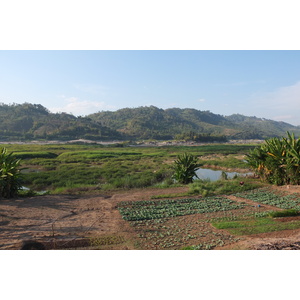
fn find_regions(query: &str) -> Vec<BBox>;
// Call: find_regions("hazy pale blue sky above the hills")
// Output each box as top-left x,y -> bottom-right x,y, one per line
0,50 -> 300,125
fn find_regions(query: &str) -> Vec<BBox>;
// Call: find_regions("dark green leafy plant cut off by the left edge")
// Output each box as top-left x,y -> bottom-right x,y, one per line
0,148 -> 22,198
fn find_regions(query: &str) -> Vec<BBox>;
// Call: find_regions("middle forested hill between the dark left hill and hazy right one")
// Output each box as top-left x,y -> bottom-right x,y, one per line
89,106 -> 235,139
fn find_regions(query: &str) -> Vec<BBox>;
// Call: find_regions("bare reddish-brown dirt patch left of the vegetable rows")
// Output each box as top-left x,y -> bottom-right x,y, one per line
0,188 -> 186,249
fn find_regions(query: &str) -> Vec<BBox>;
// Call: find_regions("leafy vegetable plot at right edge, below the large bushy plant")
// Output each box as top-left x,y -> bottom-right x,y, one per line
235,188 -> 300,210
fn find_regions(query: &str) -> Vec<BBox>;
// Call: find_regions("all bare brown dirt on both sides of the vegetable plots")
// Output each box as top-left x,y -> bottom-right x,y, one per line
0,186 -> 300,250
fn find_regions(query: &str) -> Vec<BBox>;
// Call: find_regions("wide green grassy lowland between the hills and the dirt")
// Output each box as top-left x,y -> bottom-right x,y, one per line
11,144 -> 254,196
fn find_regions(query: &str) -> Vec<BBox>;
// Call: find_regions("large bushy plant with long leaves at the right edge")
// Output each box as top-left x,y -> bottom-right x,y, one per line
247,132 -> 300,185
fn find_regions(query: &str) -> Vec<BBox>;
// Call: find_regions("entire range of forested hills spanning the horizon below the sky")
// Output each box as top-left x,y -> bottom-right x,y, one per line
0,103 -> 300,142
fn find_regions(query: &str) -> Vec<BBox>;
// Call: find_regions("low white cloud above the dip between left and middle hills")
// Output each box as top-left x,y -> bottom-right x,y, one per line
49,97 -> 116,116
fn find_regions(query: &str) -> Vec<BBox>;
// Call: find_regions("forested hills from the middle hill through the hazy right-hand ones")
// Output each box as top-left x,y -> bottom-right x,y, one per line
89,106 -> 300,141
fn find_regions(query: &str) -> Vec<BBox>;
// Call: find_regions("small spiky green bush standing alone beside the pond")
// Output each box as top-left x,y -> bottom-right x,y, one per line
173,153 -> 201,184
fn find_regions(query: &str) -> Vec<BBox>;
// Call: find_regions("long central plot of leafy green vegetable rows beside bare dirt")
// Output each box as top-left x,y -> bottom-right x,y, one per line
118,197 -> 246,221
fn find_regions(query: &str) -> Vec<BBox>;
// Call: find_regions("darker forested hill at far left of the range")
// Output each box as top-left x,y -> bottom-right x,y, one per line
0,103 -> 121,141
